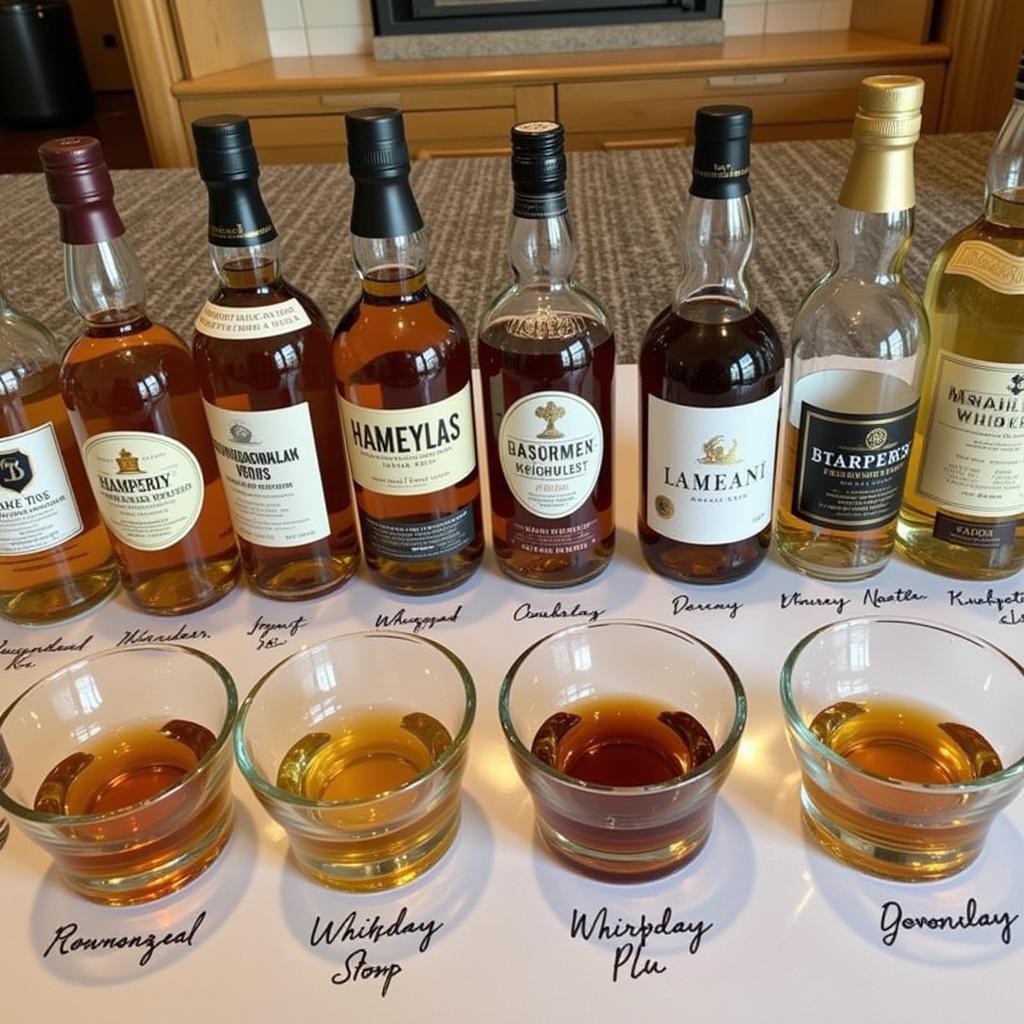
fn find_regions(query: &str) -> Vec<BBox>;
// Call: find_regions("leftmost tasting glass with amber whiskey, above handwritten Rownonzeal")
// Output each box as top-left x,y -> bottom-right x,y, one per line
0,644 -> 238,906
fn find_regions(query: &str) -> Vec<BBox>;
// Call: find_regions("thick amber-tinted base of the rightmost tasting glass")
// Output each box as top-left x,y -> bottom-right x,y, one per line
800,786 -> 984,882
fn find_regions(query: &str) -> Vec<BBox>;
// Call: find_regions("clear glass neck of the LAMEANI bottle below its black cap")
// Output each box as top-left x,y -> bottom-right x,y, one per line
675,195 -> 756,323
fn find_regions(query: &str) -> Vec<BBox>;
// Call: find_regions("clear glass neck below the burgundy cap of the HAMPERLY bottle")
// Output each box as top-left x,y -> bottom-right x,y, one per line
65,234 -> 145,327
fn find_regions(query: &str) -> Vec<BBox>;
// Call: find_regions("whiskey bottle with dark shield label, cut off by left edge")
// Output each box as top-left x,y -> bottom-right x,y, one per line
0,282 -> 118,622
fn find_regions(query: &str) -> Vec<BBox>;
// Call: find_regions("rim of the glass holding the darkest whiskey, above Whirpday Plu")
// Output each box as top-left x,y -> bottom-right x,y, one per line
498,618 -> 746,797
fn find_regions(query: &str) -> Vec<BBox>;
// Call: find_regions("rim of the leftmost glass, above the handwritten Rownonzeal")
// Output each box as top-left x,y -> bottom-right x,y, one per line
0,643 -> 239,827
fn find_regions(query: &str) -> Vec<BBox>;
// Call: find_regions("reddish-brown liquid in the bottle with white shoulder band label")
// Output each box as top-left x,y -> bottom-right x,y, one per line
193,260 -> 359,600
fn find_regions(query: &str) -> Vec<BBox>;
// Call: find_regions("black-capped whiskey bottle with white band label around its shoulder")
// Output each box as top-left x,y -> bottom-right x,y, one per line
193,115 -> 358,600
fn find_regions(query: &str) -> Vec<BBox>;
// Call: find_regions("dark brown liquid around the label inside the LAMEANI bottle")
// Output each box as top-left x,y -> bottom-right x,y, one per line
638,300 -> 784,584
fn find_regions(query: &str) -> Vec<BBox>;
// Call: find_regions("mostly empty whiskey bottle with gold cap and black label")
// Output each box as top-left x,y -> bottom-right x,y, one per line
775,75 -> 928,581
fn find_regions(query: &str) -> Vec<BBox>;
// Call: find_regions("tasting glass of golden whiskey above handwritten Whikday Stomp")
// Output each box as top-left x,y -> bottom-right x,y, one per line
234,630 -> 476,892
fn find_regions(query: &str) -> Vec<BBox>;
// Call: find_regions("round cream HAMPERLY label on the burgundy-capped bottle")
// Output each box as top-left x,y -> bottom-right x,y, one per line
82,430 -> 205,551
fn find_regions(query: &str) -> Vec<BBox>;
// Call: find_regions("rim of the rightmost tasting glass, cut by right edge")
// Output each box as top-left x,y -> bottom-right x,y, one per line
779,615 -> 1024,795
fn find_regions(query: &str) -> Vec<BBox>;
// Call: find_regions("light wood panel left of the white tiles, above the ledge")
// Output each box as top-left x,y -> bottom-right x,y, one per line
170,0 -> 270,78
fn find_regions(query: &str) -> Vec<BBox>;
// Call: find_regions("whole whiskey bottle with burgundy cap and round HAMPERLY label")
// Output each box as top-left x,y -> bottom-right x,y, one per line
39,137 -> 239,614
